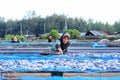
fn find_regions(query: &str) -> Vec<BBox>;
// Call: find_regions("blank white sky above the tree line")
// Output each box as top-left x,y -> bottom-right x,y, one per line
0,0 -> 120,24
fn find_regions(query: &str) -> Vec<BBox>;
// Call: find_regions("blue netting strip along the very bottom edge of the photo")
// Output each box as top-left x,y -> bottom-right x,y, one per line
18,76 -> 120,80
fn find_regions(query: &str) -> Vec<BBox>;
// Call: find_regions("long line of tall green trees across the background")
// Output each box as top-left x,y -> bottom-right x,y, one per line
0,12 -> 120,37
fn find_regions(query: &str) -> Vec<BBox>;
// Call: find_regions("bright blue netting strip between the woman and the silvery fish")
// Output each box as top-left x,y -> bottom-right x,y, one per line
0,53 -> 120,60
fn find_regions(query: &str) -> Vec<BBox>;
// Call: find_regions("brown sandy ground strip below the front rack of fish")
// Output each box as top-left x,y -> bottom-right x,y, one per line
1,72 -> 120,80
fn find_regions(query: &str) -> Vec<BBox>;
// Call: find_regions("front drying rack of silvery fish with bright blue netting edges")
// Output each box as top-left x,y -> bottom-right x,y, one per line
0,53 -> 120,72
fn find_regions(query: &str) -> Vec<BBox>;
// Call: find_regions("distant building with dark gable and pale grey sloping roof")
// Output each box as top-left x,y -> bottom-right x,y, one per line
85,30 -> 107,36
